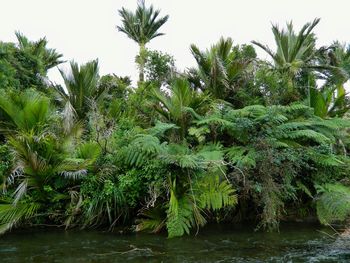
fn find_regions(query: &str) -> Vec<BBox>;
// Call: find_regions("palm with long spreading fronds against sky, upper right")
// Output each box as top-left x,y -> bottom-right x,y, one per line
252,18 -> 333,104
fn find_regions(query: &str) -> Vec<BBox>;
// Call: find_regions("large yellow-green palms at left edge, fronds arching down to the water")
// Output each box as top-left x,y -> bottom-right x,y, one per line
0,90 -> 86,234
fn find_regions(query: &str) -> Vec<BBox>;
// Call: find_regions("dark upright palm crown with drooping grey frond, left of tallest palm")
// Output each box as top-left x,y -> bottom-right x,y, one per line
56,60 -> 105,124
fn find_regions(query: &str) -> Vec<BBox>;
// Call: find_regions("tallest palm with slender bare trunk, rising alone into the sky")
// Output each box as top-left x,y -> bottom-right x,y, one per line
117,0 -> 169,82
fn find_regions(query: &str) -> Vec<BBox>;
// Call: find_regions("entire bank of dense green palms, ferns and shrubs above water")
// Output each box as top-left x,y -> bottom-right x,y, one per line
0,1 -> 350,237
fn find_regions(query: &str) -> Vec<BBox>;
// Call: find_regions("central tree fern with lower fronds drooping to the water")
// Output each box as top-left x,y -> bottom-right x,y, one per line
126,127 -> 236,237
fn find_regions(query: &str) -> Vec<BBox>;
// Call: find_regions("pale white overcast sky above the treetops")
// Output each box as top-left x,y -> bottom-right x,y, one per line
0,0 -> 350,83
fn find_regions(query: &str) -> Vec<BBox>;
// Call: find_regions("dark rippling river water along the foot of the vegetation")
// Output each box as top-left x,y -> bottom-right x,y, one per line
0,224 -> 350,263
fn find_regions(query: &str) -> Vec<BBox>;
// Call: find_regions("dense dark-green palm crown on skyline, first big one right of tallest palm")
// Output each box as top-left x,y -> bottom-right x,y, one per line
191,38 -> 255,101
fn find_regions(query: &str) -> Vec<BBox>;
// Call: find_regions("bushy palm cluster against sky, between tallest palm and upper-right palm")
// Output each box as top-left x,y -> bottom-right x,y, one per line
189,38 -> 259,105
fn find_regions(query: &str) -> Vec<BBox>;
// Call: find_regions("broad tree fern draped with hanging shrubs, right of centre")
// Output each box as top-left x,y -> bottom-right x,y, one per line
196,104 -> 349,229
